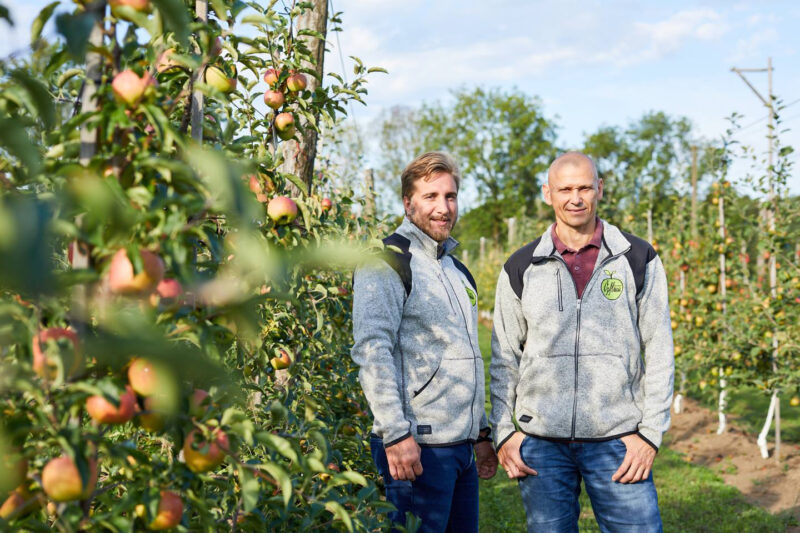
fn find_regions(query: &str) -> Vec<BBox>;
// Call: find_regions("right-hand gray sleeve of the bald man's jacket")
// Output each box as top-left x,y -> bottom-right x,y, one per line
639,256 -> 675,450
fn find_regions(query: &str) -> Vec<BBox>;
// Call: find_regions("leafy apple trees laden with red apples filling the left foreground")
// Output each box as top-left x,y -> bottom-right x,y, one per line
0,0 -> 385,531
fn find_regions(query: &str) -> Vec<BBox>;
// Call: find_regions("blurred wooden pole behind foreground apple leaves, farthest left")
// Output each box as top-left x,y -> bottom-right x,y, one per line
68,1 -> 106,333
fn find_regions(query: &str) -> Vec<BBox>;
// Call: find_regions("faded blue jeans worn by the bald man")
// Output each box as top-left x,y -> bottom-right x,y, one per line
519,436 -> 662,533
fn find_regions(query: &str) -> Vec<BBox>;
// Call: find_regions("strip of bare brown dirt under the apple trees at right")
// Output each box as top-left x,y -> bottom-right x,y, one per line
668,399 -> 800,532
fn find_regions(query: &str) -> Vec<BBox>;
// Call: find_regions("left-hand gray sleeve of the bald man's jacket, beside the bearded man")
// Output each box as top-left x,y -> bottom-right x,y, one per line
489,269 -> 528,450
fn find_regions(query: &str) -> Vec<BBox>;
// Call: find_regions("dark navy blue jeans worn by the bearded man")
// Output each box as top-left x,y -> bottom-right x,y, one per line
369,436 -> 478,533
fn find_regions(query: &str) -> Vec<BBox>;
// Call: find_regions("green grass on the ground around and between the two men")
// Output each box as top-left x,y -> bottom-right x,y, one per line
479,325 -> 794,533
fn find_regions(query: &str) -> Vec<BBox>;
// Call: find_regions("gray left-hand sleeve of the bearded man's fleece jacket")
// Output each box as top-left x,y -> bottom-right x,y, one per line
350,261 -> 411,447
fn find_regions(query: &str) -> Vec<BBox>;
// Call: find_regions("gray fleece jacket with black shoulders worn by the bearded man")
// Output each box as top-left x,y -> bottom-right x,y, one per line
351,219 -> 488,447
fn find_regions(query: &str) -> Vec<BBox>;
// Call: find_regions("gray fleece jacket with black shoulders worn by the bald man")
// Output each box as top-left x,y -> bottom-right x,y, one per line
490,221 -> 674,449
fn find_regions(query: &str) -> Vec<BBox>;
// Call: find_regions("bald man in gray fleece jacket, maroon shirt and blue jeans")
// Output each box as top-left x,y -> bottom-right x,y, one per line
490,152 -> 674,533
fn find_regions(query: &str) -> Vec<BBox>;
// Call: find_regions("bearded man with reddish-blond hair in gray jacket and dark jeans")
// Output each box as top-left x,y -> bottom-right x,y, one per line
351,152 -> 497,532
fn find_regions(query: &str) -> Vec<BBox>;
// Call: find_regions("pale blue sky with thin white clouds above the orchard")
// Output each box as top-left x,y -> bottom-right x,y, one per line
0,0 -> 800,193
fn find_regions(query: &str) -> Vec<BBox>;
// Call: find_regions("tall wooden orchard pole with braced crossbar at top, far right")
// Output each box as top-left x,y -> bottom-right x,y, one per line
731,57 -> 781,461
